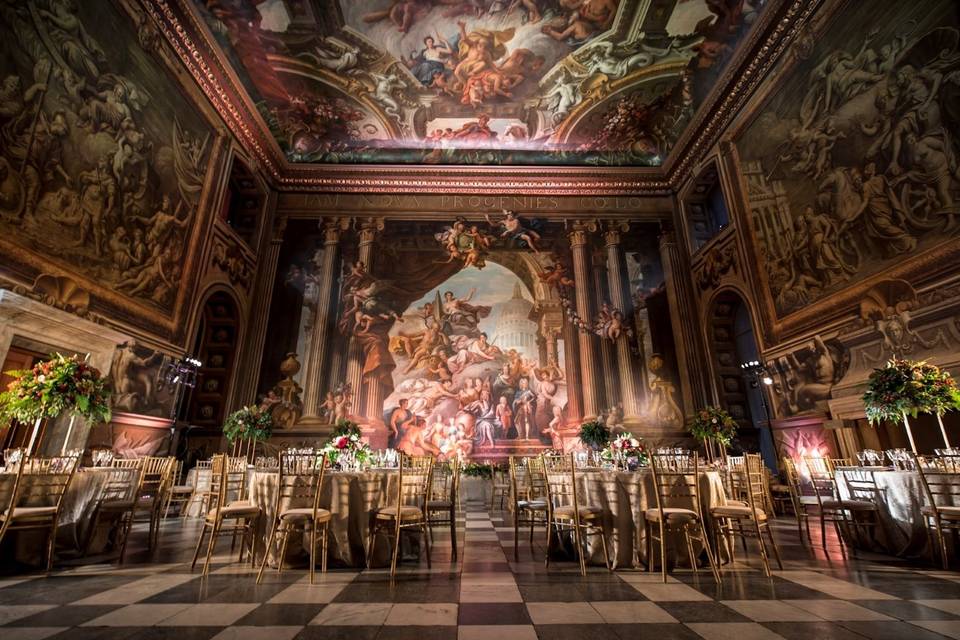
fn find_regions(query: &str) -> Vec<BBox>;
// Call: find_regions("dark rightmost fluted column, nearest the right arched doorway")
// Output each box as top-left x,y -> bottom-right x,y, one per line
660,229 -> 710,415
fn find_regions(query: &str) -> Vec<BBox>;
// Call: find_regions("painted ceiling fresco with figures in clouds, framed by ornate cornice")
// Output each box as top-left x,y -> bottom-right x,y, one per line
195,0 -> 764,167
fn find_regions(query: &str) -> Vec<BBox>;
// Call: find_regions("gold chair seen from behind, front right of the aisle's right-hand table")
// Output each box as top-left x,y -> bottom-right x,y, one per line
637,453 -> 720,584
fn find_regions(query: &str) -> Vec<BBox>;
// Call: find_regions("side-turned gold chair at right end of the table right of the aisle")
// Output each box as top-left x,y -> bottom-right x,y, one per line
710,453 -> 783,578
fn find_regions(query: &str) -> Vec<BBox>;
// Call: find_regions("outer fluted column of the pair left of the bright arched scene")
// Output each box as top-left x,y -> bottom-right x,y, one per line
303,219 -> 344,417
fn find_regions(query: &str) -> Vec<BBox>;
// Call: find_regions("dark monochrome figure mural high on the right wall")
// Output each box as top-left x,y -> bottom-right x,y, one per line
738,0 -> 960,318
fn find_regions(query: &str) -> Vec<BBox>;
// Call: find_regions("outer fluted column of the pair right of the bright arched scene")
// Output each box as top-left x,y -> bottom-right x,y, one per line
603,222 -> 646,423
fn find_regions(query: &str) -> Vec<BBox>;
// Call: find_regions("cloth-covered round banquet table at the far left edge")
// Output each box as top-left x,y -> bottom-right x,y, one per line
0,467 -> 137,565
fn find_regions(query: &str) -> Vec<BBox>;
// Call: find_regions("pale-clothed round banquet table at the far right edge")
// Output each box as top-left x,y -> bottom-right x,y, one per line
836,467 -> 960,559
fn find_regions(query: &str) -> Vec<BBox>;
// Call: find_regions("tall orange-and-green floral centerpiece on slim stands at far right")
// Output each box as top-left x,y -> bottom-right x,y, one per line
863,358 -> 960,453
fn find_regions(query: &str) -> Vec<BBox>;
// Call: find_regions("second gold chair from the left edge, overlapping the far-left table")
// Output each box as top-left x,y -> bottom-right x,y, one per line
83,458 -> 144,564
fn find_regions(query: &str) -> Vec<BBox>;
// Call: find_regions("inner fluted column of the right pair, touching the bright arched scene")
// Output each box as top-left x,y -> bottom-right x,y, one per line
570,220 -> 600,420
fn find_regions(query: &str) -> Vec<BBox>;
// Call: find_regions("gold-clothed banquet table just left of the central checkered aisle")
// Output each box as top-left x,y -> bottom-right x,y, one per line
250,469 -> 406,567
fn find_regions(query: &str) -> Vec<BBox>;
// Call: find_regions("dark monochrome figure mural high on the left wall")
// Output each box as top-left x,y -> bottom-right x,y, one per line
0,0 -> 211,311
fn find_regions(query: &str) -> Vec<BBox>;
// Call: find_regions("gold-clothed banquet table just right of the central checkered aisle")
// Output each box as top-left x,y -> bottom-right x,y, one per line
544,469 -> 727,568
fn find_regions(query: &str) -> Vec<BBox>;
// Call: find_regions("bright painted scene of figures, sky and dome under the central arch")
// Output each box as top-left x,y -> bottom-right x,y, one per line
384,263 -> 566,457
